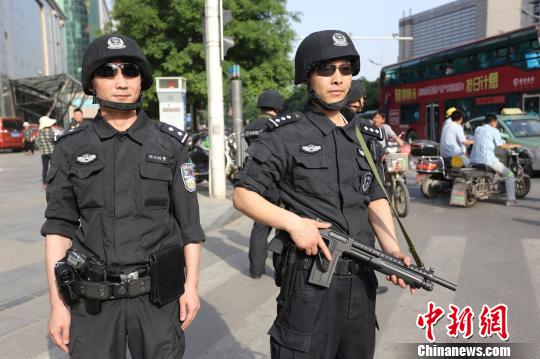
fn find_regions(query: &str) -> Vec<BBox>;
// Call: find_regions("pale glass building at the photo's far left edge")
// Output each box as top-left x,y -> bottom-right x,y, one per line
0,0 -> 66,116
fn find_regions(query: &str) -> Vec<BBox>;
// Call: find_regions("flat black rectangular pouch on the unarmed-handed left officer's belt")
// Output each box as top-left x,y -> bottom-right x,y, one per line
150,244 -> 185,306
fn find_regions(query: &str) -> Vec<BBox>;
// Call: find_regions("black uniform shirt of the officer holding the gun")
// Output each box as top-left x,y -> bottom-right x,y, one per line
235,106 -> 384,246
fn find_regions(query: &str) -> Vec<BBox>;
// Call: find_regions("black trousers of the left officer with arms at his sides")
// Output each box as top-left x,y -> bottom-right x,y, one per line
69,295 -> 185,359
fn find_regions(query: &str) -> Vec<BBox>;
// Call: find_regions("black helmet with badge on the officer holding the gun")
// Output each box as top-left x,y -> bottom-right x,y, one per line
294,30 -> 360,85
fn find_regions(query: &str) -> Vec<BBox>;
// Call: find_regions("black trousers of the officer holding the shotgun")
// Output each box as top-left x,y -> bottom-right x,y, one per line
269,270 -> 377,359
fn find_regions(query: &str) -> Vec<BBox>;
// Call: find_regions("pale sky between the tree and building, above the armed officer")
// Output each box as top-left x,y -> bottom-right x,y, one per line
287,0 -> 452,80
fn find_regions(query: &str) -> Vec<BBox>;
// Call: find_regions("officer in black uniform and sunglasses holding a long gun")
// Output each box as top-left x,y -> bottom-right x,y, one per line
233,30 -> 410,359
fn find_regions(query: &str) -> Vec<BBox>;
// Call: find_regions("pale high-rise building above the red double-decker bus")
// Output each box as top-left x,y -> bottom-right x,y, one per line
398,0 -> 540,61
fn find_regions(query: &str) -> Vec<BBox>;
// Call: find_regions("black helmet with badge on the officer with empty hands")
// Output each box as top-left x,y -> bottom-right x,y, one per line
81,34 -> 153,95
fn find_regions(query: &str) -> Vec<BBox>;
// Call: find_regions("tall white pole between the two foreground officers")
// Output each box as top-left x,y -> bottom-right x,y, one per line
204,0 -> 226,199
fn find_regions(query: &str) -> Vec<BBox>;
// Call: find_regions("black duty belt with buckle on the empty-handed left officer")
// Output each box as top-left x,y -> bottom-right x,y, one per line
74,270 -> 151,300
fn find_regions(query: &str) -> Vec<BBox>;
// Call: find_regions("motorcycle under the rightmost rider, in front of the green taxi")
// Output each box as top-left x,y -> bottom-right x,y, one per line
450,149 -> 531,207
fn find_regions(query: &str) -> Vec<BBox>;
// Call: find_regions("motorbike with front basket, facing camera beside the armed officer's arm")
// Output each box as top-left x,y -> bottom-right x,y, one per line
383,142 -> 410,217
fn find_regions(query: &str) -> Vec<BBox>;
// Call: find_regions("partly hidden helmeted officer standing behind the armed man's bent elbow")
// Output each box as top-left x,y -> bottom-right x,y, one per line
244,90 -> 283,279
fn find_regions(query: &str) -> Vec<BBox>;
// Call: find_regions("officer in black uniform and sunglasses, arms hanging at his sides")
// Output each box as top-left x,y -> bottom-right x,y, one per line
41,35 -> 205,358
